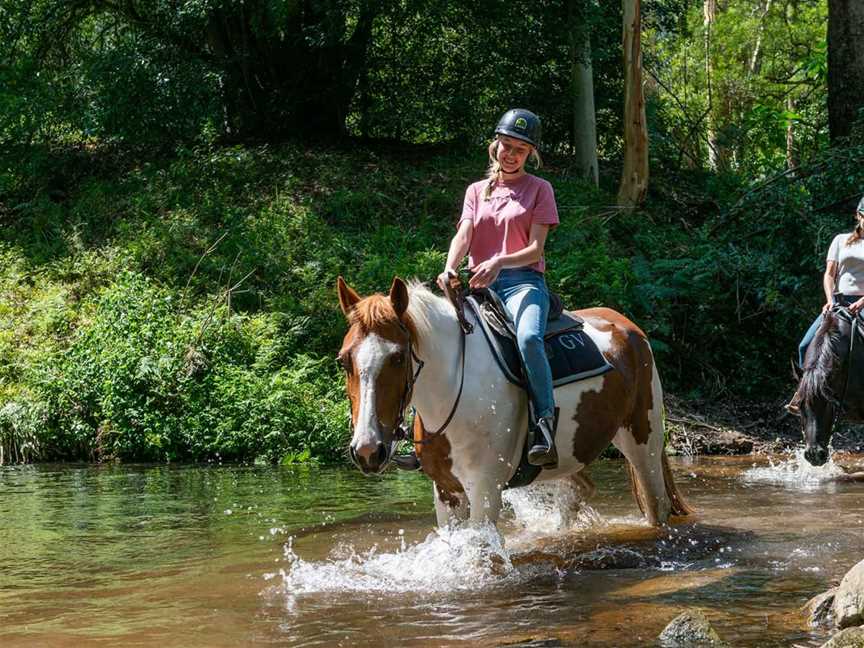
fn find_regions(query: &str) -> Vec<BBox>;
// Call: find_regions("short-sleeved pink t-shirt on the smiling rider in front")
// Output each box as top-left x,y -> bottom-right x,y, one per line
457,173 -> 558,272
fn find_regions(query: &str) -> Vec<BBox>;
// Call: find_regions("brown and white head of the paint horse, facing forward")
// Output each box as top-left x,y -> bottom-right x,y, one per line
337,277 -> 416,475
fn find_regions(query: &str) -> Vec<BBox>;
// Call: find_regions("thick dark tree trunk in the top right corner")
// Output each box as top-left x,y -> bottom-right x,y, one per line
828,0 -> 864,142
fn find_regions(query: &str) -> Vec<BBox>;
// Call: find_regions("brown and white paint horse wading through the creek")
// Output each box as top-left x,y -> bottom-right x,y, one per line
338,277 -> 691,526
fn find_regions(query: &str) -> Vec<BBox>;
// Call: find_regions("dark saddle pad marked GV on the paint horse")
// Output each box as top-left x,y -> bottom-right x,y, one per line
465,293 -> 612,388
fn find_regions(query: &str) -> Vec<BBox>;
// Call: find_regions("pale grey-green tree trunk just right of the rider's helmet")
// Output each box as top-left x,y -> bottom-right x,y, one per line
570,15 -> 600,187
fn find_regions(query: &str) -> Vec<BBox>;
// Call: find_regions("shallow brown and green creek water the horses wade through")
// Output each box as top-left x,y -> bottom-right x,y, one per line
0,456 -> 864,648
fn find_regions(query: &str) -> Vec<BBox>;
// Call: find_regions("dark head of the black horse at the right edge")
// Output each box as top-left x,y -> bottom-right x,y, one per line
798,312 -> 851,466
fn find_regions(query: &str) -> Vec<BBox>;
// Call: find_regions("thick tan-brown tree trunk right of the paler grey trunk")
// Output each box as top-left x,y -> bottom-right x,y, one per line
618,0 -> 648,207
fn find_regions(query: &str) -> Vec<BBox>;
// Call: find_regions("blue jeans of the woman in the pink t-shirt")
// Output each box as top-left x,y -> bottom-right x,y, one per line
490,268 -> 555,417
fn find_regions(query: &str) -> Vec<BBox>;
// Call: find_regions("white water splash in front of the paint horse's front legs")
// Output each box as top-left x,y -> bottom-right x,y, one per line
265,526 -> 518,597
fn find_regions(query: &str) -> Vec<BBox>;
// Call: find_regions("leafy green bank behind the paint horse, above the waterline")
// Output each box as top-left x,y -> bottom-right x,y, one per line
0,140 -> 861,461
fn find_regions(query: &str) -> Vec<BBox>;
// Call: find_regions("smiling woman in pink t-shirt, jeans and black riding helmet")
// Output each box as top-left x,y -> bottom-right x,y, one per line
438,108 -> 558,469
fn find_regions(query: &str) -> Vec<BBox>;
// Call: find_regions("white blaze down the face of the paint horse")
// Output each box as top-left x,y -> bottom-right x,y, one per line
351,333 -> 399,458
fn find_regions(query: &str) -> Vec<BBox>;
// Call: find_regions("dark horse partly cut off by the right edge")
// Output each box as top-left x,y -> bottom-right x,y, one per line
798,306 -> 864,466
